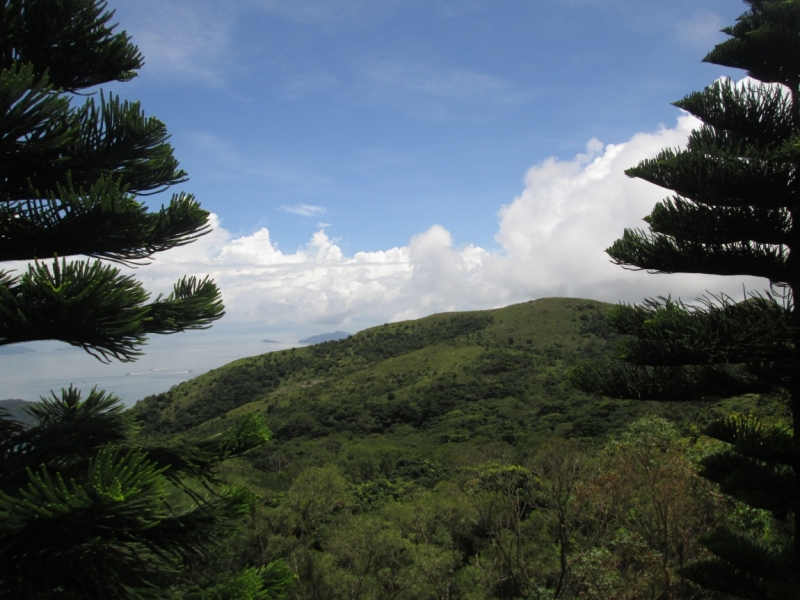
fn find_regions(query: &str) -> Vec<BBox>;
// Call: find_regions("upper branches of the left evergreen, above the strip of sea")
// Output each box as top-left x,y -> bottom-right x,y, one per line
0,0 -> 223,361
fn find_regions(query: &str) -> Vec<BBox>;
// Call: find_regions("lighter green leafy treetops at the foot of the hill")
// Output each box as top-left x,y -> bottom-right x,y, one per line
217,417 -> 724,600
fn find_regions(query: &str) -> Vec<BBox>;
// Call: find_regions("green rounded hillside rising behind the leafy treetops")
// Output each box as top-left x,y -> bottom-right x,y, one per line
135,298 -> 690,487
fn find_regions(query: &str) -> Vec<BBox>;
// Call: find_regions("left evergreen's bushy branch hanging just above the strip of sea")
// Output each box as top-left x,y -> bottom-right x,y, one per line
0,260 -> 224,362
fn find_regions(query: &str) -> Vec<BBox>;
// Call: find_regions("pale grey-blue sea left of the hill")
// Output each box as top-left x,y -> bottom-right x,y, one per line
0,329 -> 303,406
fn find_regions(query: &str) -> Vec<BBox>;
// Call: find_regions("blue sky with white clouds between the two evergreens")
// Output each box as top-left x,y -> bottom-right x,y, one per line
87,0 -> 764,333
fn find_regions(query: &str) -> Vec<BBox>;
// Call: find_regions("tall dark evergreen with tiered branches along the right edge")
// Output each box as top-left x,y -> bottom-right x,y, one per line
572,0 -> 800,599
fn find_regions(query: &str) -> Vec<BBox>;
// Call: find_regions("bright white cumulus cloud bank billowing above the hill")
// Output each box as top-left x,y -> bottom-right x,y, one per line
131,116 -> 766,329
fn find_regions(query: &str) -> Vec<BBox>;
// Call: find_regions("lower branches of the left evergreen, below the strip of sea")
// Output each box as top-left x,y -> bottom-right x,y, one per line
0,388 -> 276,598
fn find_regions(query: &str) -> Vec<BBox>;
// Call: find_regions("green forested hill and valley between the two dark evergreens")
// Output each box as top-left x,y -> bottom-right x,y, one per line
133,298 -> 790,600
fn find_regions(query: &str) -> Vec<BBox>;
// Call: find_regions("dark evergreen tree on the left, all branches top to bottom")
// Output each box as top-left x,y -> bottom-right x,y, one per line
0,0 -> 292,598
